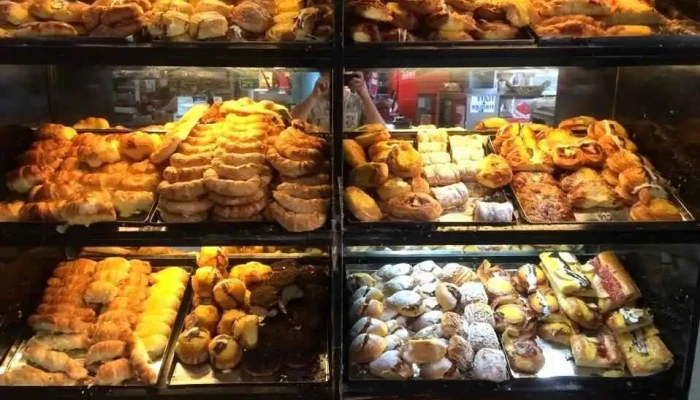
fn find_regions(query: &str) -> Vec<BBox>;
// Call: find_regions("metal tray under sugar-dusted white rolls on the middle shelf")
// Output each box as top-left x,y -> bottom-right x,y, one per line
346,129 -> 517,225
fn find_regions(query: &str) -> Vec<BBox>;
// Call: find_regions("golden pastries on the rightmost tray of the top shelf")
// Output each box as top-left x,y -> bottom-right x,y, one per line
533,0 -> 666,37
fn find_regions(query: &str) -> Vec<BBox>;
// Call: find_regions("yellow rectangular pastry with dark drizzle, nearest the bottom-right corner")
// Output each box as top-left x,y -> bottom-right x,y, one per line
616,326 -> 673,376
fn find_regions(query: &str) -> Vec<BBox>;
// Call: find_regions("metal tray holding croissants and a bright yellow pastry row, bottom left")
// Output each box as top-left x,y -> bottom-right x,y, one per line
0,264 -> 196,386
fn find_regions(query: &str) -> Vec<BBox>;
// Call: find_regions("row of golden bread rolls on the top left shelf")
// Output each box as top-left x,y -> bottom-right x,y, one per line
0,0 -> 333,41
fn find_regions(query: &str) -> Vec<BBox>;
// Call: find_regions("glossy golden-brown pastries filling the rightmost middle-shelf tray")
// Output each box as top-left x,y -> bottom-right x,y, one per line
500,116 -> 682,222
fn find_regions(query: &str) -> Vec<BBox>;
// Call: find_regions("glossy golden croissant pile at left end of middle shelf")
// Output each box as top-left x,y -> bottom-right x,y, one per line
0,118 -> 161,225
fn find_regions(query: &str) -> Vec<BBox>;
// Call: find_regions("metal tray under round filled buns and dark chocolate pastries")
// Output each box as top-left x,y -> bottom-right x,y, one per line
166,260 -> 331,387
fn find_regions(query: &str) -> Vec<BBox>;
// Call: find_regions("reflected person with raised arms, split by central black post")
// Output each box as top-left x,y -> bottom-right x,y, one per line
291,73 -> 384,130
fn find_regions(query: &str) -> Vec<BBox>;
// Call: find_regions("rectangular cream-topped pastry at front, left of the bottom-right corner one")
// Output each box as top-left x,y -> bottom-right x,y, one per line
571,331 -> 623,368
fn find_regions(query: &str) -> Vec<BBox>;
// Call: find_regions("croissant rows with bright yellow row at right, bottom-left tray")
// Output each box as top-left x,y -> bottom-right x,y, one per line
0,257 -> 189,386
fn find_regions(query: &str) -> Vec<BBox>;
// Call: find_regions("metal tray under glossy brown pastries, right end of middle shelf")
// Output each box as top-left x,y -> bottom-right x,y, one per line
513,181 -> 695,224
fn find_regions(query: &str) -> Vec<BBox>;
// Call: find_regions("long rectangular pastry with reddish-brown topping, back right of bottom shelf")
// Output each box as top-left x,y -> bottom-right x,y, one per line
586,251 -> 641,313
